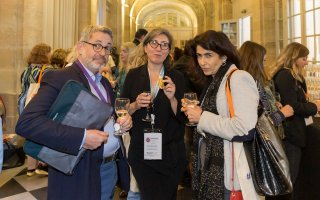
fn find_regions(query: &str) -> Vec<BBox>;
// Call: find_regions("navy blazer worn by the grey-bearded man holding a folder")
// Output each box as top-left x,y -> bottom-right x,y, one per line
16,63 -> 114,200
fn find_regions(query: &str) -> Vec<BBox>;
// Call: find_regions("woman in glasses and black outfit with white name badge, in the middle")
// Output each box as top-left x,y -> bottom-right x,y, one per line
121,28 -> 186,200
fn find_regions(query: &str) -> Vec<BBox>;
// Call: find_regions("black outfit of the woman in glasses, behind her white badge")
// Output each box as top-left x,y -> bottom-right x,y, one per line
121,65 -> 186,200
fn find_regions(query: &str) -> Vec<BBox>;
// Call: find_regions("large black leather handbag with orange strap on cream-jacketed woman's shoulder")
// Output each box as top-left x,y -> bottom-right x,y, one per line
226,71 -> 292,196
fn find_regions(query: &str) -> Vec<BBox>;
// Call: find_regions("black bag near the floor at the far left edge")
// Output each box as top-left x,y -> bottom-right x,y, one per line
2,139 -> 25,169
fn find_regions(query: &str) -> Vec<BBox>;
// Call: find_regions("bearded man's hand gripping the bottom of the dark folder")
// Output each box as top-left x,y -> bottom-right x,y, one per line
83,130 -> 109,150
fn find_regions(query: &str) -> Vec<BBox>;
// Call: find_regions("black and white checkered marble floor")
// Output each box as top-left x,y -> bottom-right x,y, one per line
0,162 -> 191,200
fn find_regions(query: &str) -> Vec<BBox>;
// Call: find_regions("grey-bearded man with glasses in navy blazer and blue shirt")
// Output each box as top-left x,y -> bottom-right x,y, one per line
16,25 -> 132,200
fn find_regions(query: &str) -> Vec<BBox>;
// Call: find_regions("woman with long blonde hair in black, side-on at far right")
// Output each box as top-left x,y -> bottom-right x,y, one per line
270,42 -> 320,199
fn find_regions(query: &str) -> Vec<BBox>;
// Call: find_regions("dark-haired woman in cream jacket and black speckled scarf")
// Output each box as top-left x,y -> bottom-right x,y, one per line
182,30 -> 259,200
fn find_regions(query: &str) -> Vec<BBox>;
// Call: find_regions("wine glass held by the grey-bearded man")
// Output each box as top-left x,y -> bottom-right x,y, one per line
114,98 -> 130,136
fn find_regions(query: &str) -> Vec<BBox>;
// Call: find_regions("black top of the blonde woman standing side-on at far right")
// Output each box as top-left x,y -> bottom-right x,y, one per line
273,69 -> 317,147
